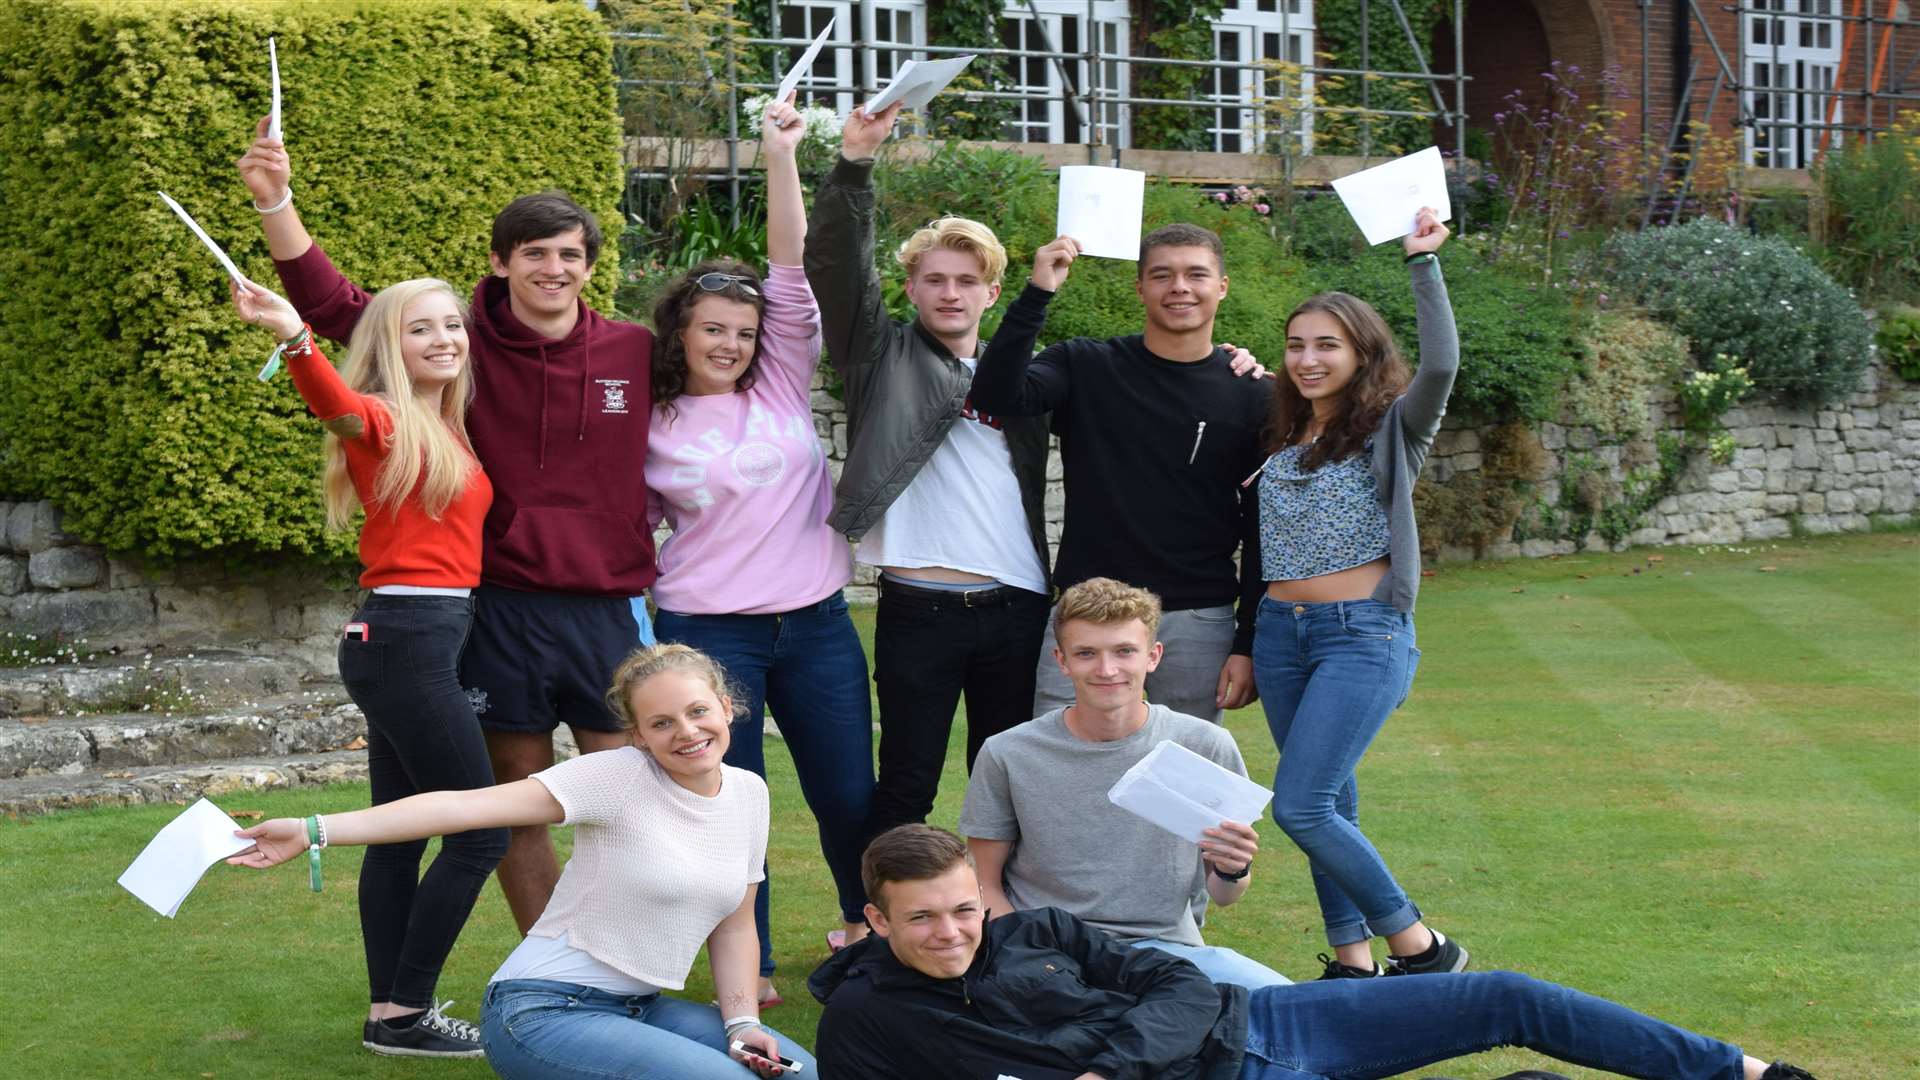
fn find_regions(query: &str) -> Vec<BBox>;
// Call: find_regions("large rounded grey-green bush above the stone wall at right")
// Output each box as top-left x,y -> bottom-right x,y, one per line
1607,219 -> 1872,407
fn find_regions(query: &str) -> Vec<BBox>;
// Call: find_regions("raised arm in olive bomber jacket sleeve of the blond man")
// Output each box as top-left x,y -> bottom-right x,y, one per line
804,104 -> 900,390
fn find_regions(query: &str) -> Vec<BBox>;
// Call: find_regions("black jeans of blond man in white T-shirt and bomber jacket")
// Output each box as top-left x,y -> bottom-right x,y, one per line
866,578 -> 1050,838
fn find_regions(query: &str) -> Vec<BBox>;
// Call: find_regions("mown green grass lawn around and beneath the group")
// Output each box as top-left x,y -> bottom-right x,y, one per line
0,534 -> 1920,1080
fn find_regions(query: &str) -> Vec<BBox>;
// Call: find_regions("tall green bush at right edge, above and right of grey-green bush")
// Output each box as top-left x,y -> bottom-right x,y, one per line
1818,113 -> 1920,304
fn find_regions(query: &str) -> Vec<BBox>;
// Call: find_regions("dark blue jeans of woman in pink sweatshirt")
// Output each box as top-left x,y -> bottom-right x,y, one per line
653,592 -> 874,974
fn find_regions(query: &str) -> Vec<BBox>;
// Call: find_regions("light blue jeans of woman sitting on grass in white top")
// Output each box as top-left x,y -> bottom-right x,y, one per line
480,978 -> 814,1080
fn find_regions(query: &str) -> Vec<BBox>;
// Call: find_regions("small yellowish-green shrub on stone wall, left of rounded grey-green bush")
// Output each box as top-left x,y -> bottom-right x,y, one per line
1567,311 -> 1688,442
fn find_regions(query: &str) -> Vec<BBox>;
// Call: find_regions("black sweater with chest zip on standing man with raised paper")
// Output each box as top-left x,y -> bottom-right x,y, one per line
972,284 -> 1271,655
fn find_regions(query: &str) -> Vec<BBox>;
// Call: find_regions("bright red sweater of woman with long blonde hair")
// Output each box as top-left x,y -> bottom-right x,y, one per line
286,336 -> 493,588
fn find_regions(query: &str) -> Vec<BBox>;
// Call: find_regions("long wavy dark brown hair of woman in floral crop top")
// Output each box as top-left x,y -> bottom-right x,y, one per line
1265,292 -> 1409,471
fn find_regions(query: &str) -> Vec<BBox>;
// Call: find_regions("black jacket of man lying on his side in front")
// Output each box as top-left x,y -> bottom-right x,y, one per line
806,907 -> 1246,1080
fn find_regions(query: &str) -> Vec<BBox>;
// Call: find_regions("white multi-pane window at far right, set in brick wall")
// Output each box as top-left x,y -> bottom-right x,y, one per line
1740,0 -> 1841,169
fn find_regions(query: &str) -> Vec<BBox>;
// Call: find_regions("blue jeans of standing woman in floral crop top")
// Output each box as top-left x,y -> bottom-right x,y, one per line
1254,598 -> 1421,945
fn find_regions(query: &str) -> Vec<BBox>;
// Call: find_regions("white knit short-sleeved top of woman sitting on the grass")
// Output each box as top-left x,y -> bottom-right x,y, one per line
528,746 -> 768,990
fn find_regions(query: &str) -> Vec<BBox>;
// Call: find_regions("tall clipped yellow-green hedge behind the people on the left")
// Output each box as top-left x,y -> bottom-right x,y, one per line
0,0 -> 620,557
